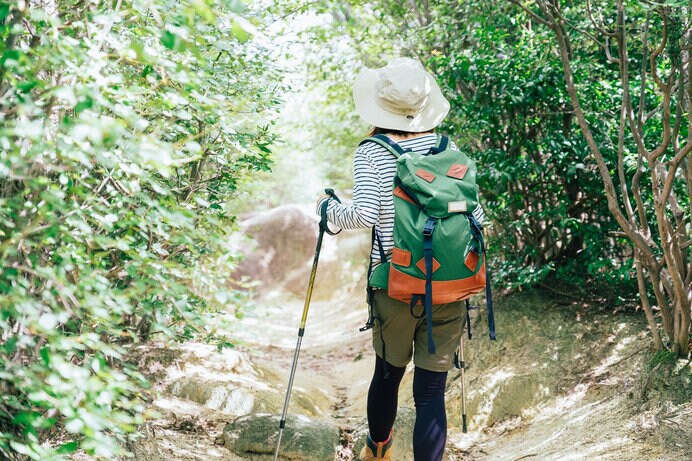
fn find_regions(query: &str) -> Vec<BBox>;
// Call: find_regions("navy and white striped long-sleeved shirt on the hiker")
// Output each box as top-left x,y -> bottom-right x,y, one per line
327,134 -> 485,263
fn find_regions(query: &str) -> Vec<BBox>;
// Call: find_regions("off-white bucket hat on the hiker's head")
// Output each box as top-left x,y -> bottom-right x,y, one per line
353,58 -> 449,133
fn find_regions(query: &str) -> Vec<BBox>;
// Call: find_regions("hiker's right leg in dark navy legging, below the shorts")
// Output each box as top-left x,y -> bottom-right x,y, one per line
413,367 -> 447,461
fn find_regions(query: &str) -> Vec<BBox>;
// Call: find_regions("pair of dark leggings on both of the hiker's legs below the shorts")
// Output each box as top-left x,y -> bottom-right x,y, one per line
368,357 -> 447,461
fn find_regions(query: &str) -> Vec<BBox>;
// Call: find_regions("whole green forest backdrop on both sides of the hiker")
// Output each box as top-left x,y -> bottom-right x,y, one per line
0,0 -> 692,460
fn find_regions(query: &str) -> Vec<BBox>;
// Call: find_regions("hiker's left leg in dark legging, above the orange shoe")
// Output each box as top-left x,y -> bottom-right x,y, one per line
368,357 -> 406,442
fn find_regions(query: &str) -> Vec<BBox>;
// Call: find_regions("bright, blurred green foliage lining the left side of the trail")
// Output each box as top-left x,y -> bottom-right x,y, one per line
0,0 -> 282,461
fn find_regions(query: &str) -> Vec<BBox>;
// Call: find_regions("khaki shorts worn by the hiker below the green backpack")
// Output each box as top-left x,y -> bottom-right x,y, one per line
372,290 -> 466,371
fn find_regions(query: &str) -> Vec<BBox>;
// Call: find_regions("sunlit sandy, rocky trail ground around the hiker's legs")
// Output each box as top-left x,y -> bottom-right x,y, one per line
128,286 -> 692,461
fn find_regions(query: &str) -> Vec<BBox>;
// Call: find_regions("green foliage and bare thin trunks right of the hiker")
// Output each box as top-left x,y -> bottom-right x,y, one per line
270,0 -> 692,355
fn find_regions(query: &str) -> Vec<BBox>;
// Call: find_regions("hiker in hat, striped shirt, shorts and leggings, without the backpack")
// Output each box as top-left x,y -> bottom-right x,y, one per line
317,58 -> 485,461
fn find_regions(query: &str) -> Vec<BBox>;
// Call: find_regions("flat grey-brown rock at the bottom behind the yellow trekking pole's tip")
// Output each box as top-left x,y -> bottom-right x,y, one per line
223,414 -> 339,461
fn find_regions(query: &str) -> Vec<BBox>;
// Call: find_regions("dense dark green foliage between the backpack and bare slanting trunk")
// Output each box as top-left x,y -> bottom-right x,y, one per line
428,1 -> 621,287
